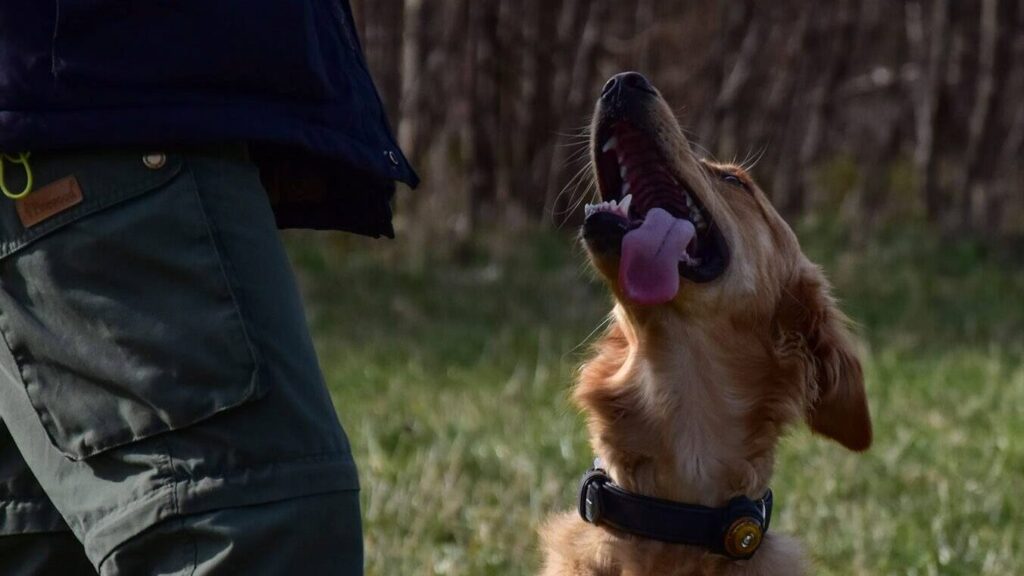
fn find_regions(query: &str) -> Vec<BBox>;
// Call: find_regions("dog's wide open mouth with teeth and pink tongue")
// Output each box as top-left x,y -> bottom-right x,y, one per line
586,120 -> 728,303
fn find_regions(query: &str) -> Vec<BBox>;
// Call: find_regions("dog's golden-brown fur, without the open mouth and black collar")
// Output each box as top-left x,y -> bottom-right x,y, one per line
542,83 -> 871,576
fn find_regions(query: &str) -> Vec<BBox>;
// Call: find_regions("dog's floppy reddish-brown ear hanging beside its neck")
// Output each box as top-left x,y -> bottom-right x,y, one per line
782,264 -> 871,451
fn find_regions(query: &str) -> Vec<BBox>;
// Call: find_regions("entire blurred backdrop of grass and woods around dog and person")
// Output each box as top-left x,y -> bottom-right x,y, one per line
286,0 -> 1024,576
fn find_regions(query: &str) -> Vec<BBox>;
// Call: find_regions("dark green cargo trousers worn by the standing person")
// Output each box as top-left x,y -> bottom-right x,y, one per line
0,146 -> 362,576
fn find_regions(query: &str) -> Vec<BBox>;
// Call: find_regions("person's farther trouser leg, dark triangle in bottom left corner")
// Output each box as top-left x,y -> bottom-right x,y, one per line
0,421 -> 96,576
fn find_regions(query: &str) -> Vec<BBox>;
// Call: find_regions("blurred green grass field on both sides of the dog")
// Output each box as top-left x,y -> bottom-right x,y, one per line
289,224 -> 1024,576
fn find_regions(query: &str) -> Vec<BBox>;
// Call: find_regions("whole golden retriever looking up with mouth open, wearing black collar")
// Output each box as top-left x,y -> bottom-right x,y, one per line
542,73 -> 871,576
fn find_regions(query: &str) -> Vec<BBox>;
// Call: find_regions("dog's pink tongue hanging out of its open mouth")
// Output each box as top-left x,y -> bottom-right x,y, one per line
618,208 -> 696,304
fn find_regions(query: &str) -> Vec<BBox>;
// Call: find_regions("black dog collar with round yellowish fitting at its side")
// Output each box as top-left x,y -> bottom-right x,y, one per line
580,462 -> 772,560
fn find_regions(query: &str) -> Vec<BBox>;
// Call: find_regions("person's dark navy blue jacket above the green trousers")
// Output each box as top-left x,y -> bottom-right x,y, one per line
0,0 -> 418,236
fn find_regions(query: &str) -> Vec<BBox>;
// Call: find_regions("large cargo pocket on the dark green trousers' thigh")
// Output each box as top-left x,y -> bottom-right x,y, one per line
0,155 -> 264,460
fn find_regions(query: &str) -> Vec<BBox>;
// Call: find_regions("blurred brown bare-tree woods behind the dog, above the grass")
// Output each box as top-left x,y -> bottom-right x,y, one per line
353,0 -> 1024,240
